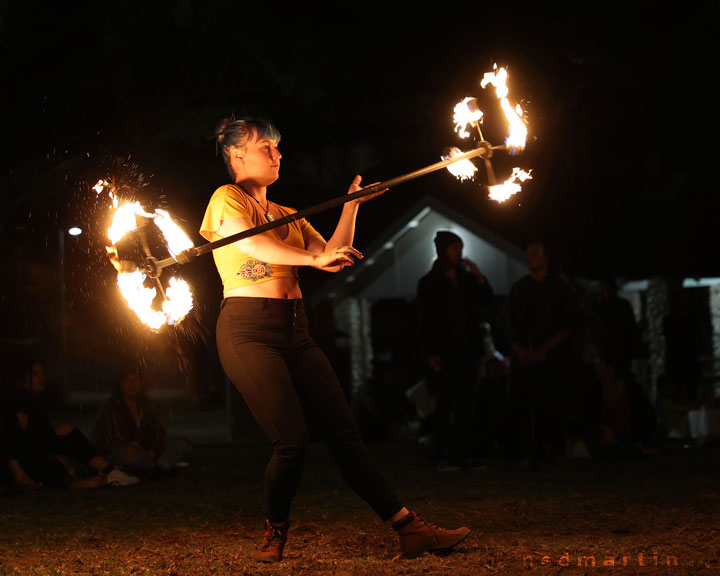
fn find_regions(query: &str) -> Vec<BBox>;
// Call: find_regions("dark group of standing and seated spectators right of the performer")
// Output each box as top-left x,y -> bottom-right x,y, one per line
356,231 -> 717,471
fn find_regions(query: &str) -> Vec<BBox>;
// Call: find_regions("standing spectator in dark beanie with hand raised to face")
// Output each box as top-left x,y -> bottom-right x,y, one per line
417,230 -> 493,469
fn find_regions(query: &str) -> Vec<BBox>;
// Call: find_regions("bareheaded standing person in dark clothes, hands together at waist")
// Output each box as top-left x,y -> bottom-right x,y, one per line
503,242 -> 575,467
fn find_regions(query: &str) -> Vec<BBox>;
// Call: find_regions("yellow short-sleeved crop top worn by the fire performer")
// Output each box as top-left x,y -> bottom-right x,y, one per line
200,184 -> 320,290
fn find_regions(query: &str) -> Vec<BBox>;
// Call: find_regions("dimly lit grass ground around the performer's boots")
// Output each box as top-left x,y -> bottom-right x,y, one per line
0,416 -> 720,576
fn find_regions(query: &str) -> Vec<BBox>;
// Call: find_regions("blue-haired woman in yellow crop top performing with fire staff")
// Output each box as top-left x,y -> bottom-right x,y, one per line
200,118 -> 470,562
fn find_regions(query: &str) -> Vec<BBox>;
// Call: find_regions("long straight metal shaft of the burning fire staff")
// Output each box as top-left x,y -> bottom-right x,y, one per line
145,141 -> 505,278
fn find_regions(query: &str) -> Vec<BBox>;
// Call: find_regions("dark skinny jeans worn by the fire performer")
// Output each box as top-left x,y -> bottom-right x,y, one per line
217,297 -> 402,522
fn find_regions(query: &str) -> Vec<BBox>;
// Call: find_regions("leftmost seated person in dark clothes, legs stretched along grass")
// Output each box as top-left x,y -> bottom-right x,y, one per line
2,362 -> 139,492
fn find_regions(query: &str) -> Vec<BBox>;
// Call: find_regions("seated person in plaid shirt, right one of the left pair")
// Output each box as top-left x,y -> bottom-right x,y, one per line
94,368 -> 192,472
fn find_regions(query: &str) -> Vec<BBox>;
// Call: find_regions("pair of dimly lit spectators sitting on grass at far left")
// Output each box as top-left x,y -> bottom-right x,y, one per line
0,359 -> 192,493
